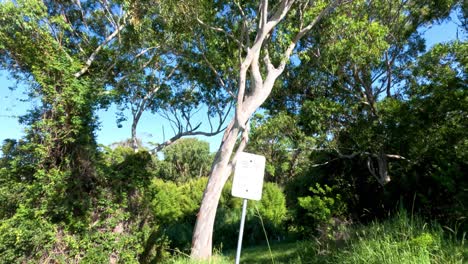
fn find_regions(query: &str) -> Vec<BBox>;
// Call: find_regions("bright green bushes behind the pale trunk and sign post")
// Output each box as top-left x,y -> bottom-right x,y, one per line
147,177 -> 288,252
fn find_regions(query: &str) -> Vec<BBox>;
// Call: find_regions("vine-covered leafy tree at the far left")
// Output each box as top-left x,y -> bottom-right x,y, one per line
0,0 -> 122,193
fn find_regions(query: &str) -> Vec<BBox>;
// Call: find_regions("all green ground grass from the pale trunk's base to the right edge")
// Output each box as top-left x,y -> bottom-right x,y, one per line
164,212 -> 468,264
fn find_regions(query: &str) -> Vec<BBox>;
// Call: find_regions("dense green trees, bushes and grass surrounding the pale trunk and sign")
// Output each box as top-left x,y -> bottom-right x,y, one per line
0,0 -> 468,263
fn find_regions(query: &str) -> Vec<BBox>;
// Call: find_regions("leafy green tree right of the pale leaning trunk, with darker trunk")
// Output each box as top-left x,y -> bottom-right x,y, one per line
266,1 -> 456,185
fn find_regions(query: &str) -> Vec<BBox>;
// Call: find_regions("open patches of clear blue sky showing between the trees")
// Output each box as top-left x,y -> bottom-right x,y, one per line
0,12 -> 462,151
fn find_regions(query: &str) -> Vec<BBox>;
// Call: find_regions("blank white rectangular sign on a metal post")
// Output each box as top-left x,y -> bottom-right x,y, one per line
232,152 -> 265,201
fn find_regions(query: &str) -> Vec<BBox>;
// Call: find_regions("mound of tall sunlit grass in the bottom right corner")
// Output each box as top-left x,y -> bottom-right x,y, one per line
329,210 -> 468,264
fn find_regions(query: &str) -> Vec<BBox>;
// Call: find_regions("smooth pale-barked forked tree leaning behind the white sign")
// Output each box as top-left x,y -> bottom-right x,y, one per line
170,0 -> 346,259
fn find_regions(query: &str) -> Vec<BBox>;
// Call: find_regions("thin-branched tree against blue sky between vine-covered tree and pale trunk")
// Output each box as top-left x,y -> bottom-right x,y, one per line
109,20 -> 229,152
